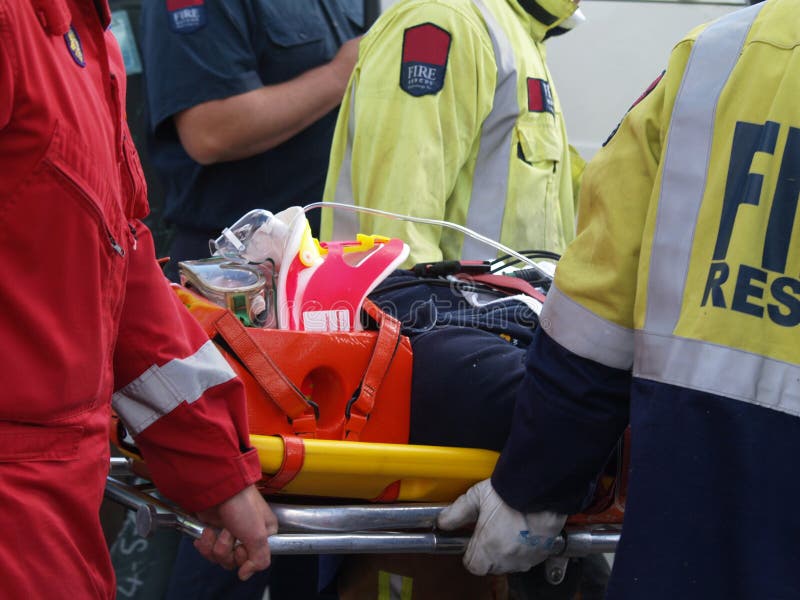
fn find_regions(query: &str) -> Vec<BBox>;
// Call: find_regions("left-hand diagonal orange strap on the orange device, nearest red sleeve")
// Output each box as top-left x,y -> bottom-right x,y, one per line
214,311 -> 317,437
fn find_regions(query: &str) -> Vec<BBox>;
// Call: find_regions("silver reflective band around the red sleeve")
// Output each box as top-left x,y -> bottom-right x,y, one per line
112,341 -> 236,436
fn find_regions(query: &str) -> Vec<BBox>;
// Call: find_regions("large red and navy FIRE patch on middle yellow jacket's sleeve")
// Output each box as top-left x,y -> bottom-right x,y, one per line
400,23 -> 452,96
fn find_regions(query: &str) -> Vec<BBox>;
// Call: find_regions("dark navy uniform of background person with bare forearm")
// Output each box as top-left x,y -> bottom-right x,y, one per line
142,0 -> 364,231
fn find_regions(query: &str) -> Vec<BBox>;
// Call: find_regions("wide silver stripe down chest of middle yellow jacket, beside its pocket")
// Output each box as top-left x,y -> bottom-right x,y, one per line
461,0 -> 520,260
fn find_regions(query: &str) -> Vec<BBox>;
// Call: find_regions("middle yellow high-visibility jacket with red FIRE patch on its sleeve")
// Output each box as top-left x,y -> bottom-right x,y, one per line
322,0 -> 583,264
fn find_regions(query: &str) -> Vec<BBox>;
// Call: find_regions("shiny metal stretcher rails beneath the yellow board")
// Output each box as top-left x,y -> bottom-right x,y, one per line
105,459 -> 620,558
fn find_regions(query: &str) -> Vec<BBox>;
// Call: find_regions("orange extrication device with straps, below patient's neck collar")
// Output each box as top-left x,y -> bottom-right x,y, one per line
173,285 -> 412,500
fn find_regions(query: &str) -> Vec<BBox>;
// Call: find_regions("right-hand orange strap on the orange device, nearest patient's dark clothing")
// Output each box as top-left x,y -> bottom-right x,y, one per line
344,300 -> 401,441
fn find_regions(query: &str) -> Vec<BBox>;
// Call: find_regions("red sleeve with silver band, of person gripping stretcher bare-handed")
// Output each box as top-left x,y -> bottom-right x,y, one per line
114,222 -> 261,511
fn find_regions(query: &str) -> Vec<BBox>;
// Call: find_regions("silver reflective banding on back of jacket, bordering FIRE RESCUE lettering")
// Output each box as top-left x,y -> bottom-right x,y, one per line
636,4 -> 800,416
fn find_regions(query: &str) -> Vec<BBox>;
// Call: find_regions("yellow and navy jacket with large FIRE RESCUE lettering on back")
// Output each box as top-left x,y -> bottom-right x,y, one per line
492,0 -> 800,600
